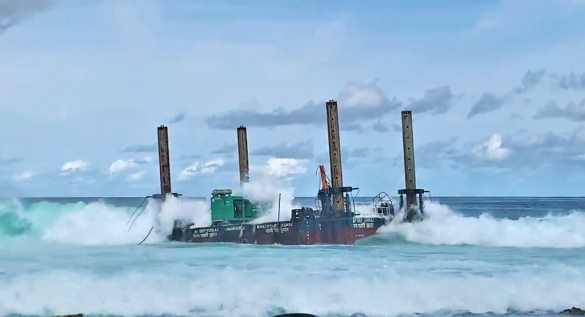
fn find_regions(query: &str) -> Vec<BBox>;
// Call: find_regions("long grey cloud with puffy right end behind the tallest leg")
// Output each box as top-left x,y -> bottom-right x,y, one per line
206,82 -> 400,131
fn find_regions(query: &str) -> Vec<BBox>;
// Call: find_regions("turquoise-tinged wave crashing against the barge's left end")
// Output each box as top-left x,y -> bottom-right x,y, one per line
0,199 -> 211,245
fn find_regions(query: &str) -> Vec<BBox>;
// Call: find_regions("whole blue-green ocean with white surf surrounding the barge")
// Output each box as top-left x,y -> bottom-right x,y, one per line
0,197 -> 585,317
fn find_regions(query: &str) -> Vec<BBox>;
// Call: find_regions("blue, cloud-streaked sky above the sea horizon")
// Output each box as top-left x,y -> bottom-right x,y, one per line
0,0 -> 585,197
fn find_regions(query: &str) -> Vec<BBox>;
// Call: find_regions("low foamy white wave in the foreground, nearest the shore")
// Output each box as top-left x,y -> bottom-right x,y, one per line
0,254 -> 585,317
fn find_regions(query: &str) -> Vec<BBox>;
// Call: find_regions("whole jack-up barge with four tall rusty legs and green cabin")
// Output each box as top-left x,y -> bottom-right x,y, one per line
152,100 -> 427,245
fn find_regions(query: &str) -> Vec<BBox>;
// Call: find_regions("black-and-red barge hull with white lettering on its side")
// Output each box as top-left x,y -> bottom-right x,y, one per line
169,217 -> 388,245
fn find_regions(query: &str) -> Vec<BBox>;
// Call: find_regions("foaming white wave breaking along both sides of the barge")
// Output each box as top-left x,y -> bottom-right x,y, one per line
0,195 -> 585,248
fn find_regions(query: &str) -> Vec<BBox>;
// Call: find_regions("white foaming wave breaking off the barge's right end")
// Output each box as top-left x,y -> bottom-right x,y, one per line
377,202 -> 585,248
